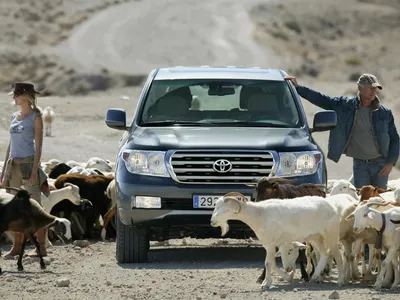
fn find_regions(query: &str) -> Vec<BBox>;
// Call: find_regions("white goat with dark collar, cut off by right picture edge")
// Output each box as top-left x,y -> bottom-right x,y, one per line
346,202 -> 400,289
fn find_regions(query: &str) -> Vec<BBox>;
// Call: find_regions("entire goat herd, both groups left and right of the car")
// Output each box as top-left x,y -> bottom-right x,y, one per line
0,157 -> 400,289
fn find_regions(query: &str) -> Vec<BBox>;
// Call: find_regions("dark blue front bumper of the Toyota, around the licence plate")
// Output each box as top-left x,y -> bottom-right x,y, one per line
116,169 -> 323,226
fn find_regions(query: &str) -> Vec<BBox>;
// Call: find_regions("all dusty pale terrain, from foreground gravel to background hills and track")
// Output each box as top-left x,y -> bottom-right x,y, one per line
0,0 -> 400,300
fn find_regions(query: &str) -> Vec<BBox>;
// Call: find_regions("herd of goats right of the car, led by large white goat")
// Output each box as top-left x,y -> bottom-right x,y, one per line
211,178 -> 400,289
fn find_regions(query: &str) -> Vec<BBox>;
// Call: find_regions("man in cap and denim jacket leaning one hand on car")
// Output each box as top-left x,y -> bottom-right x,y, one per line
285,74 -> 399,189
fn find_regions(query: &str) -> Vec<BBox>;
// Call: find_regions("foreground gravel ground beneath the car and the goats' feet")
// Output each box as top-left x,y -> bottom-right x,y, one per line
0,239 -> 399,300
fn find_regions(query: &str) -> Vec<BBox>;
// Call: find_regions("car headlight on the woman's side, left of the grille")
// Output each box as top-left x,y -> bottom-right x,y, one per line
122,150 -> 169,177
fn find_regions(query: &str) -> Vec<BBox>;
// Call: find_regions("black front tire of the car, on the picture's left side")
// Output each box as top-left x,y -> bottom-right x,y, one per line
116,211 -> 150,263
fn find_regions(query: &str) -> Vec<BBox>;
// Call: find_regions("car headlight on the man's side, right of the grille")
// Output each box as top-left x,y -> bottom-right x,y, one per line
276,151 -> 322,177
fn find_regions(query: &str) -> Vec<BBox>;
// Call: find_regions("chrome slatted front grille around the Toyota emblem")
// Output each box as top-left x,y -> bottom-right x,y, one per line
171,151 -> 275,184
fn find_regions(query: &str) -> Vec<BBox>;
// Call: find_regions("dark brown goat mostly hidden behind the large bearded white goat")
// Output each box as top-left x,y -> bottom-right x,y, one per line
250,177 -> 326,283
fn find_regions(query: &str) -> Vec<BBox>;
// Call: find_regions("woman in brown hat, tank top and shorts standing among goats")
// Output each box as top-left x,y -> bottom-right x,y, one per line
0,83 -> 49,257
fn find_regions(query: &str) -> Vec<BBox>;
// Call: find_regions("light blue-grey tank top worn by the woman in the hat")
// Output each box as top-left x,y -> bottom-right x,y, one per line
10,112 -> 37,158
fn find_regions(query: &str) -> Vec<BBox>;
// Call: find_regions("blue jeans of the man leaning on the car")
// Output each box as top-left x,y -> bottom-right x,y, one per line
353,158 -> 389,189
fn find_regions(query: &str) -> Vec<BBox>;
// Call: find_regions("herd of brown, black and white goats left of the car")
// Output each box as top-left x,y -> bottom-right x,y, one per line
0,157 -> 116,273
